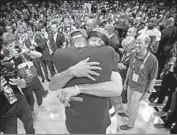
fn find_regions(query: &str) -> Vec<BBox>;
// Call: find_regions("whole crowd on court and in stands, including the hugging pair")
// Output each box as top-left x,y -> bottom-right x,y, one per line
0,0 -> 177,134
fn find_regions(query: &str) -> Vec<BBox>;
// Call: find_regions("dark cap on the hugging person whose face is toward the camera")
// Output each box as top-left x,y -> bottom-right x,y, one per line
88,28 -> 109,45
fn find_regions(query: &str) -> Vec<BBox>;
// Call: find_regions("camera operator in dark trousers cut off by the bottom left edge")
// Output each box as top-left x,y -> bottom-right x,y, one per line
0,48 -> 35,134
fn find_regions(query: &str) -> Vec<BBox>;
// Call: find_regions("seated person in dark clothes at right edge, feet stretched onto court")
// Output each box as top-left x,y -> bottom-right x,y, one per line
151,41 -> 177,116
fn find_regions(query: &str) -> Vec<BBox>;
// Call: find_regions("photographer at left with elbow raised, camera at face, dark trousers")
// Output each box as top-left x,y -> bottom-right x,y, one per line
3,33 -> 48,115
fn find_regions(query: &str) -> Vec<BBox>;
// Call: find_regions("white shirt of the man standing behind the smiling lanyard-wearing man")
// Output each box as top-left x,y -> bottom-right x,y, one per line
138,26 -> 161,41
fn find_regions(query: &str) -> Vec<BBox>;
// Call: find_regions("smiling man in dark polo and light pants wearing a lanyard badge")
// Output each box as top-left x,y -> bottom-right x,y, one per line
119,36 -> 158,130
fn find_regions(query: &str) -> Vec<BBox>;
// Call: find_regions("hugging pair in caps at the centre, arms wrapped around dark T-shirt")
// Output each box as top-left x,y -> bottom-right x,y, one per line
49,29 -> 122,134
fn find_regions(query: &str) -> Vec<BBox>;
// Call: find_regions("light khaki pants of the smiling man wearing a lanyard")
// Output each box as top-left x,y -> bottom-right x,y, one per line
126,88 -> 143,127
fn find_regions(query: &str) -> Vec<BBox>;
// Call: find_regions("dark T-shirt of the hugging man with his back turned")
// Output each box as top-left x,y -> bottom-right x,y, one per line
54,46 -> 116,134
